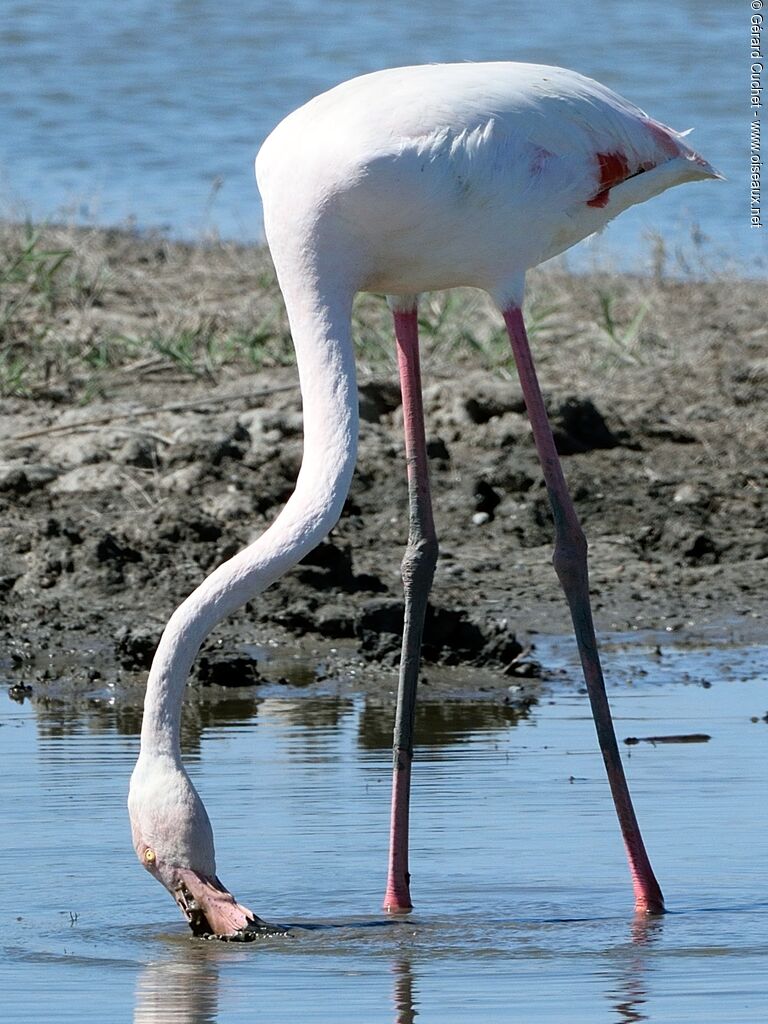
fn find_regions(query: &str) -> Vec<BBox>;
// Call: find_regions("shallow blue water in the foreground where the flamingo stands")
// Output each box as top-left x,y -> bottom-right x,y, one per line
0,642 -> 768,1024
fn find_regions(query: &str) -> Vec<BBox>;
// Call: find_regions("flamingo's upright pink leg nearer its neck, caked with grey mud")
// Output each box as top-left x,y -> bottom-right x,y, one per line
384,307 -> 437,911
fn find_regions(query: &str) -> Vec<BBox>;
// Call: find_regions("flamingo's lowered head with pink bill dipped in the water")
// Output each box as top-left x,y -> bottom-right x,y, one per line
128,758 -> 281,941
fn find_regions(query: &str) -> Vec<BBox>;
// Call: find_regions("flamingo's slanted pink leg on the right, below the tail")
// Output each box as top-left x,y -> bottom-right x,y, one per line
504,306 -> 664,913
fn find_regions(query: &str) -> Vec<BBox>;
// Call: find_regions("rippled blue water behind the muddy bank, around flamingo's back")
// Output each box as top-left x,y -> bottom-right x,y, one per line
0,0 -> 766,272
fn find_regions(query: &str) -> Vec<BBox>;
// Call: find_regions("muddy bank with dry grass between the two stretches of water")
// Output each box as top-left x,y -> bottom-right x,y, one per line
0,226 -> 768,700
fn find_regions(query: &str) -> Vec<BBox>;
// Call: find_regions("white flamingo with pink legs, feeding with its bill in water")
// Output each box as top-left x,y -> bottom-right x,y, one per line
129,62 -> 720,938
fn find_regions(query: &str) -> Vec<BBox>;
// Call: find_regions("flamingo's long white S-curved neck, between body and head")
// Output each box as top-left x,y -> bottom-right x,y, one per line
141,263 -> 357,760
